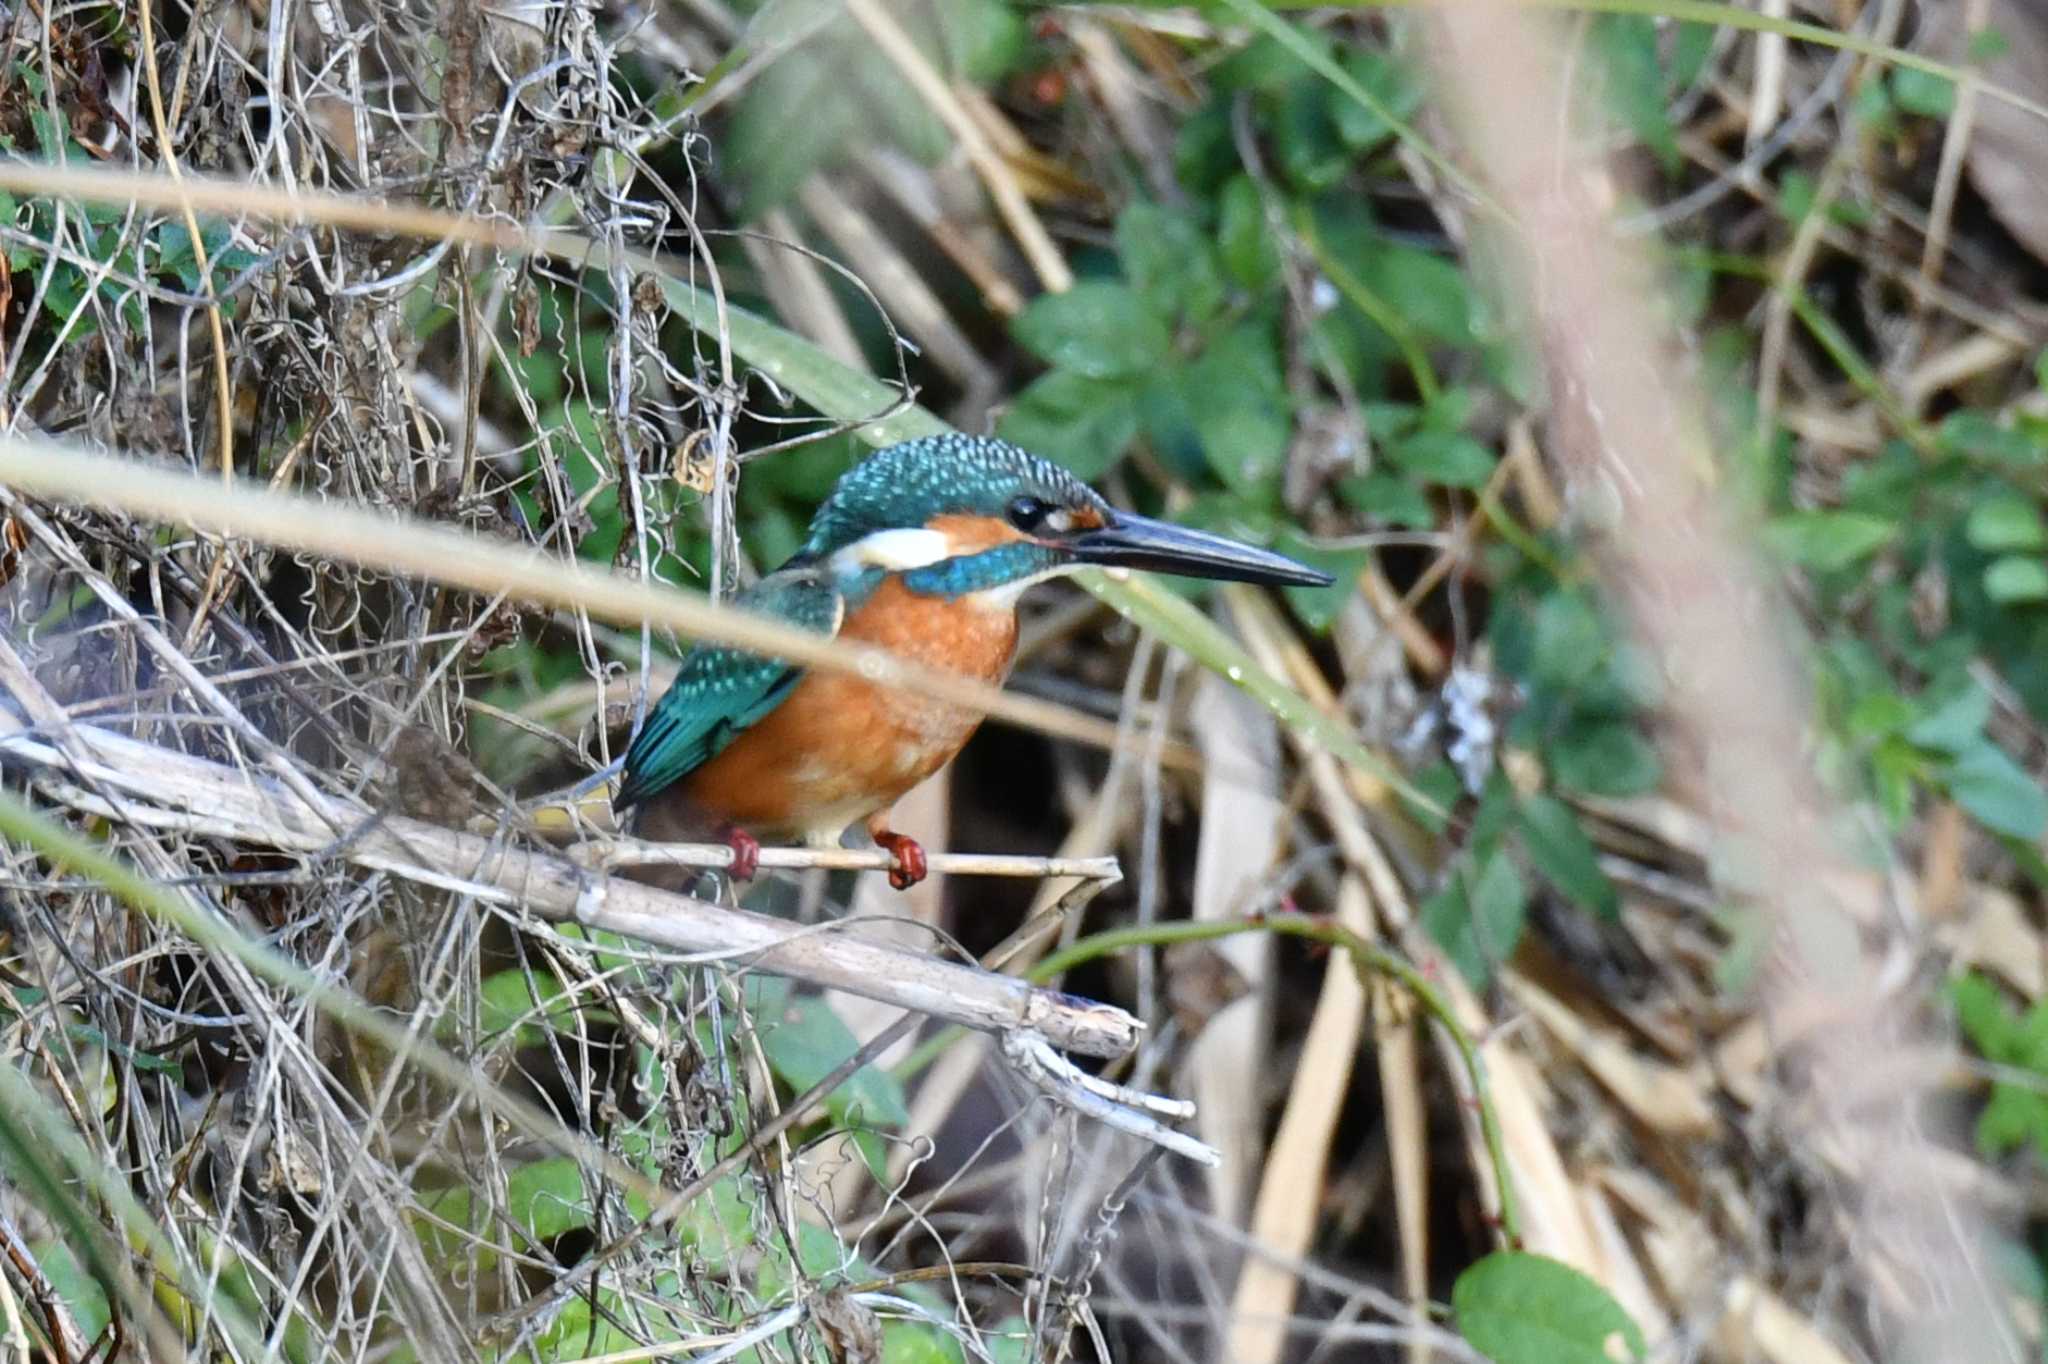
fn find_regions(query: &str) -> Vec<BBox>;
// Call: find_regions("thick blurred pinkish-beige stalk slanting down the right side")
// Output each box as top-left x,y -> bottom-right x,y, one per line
1430,2 -> 2021,1362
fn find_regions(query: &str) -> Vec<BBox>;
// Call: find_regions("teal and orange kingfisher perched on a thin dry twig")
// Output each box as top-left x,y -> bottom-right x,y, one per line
612,434 -> 1331,891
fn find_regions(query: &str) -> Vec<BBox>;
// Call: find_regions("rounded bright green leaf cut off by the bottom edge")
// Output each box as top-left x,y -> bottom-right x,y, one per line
1450,1251 -> 1649,1364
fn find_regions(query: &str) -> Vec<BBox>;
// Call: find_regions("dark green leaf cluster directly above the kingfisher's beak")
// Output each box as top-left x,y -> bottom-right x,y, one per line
997,37 -> 1509,629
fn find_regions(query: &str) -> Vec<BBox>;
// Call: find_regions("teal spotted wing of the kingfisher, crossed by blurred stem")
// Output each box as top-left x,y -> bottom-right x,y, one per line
612,567 -> 846,809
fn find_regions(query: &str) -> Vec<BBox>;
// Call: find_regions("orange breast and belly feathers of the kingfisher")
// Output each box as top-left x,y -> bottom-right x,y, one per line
684,576 -> 1018,836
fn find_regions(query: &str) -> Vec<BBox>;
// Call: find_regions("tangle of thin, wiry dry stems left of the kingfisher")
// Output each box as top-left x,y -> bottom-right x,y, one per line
0,0 -> 1187,1360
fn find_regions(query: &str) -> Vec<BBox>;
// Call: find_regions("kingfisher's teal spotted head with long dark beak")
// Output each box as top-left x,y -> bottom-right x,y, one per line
803,436 -> 1329,596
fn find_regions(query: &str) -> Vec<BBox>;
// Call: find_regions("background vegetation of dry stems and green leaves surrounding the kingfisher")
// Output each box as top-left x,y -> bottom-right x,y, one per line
0,0 -> 2048,1364
